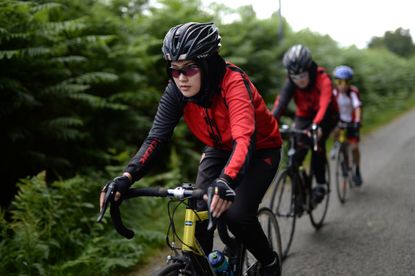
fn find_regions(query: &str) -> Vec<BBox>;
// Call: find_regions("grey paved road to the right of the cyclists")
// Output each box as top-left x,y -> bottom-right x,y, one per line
283,110 -> 415,276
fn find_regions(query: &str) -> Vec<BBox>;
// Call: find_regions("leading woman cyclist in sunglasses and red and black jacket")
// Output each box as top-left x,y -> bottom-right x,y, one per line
100,22 -> 282,275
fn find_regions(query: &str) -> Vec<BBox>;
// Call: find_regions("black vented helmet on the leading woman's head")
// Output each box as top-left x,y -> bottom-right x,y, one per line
162,22 -> 221,61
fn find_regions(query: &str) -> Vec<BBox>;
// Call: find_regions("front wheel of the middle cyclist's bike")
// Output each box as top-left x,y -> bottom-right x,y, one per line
270,170 -> 297,259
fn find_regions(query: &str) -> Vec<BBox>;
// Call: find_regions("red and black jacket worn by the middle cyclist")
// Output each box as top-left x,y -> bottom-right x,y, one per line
273,67 -> 338,124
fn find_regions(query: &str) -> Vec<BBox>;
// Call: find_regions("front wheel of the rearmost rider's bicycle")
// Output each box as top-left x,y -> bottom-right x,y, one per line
335,146 -> 350,204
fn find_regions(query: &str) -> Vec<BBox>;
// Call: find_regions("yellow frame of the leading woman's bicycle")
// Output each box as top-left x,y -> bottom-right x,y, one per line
182,208 -> 208,256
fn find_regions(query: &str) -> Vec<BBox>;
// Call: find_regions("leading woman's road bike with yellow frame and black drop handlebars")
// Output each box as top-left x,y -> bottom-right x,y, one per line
98,183 -> 281,276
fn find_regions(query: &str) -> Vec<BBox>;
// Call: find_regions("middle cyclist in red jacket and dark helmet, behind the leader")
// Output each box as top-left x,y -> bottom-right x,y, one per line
273,44 -> 339,203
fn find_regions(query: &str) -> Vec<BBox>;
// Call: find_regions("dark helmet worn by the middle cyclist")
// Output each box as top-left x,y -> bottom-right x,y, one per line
282,44 -> 313,75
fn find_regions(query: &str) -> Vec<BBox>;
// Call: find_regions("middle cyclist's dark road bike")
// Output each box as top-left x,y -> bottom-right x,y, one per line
270,125 -> 330,259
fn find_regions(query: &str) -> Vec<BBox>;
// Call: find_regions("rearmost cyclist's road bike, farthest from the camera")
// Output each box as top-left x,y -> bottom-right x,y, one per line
332,122 -> 355,204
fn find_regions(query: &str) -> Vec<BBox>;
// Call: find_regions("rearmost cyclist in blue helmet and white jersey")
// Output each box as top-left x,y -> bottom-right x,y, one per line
332,65 -> 363,186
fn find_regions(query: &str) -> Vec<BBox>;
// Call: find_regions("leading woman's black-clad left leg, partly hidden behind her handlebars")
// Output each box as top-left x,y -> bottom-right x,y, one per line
195,147 -> 230,254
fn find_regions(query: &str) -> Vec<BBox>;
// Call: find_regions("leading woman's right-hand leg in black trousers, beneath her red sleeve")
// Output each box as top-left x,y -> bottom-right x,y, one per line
225,149 -> 280,265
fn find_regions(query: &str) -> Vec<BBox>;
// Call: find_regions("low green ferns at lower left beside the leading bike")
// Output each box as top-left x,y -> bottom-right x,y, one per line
0,173 -> 171,275
